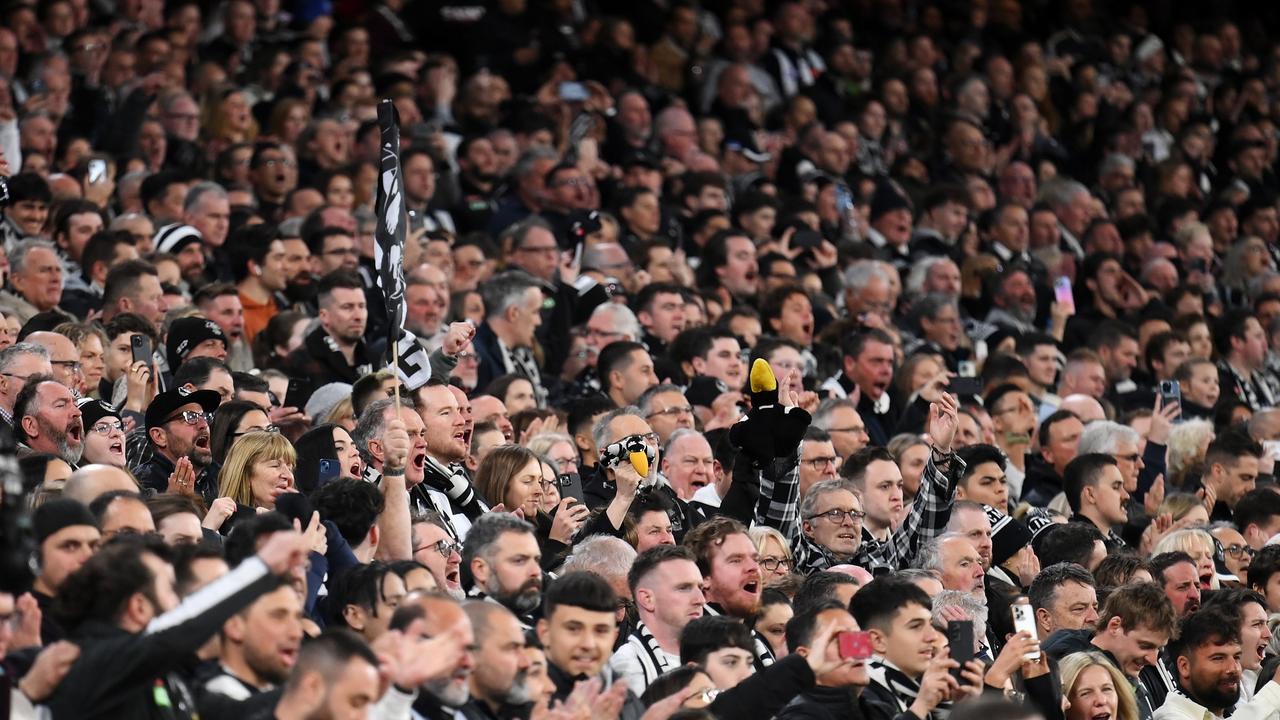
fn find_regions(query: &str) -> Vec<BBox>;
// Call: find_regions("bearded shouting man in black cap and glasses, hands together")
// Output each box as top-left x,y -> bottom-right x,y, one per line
134,387 -> 221,502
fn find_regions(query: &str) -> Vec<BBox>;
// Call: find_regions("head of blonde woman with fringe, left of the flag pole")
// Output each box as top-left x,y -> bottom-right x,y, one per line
218,432 -> 298,510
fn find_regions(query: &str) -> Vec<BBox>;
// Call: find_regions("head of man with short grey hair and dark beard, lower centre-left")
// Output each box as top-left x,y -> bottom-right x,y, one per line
462,512 -> 543,630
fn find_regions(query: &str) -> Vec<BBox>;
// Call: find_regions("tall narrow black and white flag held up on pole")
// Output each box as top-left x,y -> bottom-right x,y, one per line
374,100 -> 431,391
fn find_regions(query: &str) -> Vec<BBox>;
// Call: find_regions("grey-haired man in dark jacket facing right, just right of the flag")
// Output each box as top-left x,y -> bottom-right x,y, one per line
474,270 -> 554,399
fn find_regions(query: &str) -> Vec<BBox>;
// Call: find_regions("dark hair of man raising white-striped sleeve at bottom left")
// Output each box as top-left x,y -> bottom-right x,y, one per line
54,533 -> 172,630
